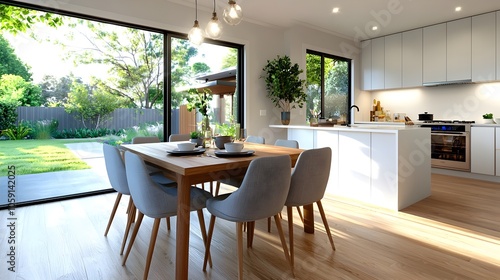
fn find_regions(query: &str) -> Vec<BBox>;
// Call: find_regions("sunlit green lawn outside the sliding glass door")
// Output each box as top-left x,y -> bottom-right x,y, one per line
0,139 -> 95,176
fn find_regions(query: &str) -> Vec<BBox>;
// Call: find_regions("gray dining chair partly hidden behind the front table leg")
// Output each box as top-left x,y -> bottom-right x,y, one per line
122,151 -> 212,279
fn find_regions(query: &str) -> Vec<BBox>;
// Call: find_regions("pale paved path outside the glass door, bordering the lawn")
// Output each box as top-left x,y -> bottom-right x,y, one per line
0,142 -> 111,207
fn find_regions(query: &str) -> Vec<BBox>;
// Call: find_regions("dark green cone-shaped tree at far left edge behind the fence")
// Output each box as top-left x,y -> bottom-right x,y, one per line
0,34 -> 31,81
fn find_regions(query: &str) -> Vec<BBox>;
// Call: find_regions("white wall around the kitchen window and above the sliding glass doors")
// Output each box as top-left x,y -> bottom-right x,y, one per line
14,0 -> 363,143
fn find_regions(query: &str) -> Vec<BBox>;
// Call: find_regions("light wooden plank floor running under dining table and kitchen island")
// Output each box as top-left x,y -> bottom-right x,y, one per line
0,174 -> 500,280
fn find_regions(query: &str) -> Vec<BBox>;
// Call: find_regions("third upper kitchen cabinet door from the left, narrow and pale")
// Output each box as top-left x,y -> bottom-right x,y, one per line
384,33 -> 402,89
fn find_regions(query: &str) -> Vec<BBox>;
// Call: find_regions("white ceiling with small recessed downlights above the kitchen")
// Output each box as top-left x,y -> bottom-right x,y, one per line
171,0 -> 500,39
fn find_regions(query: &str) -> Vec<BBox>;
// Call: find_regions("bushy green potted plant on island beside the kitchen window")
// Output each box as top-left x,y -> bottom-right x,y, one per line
262,55 -> 307,125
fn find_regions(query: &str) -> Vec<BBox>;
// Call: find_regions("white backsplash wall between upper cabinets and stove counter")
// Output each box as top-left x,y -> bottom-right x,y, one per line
368,83 -> 500,123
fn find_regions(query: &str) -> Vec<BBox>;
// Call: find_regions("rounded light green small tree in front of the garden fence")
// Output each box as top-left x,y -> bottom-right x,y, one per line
64,81 -> 123,129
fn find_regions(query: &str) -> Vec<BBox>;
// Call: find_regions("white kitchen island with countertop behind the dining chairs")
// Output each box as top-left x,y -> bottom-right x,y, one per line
270,125 -> 431,210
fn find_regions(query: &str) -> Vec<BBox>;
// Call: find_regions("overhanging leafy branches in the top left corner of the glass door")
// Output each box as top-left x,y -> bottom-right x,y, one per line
0,4 -> 63,34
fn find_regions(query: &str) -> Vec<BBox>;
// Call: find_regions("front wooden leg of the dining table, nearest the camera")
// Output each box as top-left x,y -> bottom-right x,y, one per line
175,175 -> 191,280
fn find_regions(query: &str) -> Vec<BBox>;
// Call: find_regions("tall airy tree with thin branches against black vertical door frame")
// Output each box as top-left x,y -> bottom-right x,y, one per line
62,20 -> 164,108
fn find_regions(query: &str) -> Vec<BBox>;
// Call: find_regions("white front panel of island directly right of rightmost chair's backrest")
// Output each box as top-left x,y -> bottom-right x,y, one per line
335,131 -> 371,202
